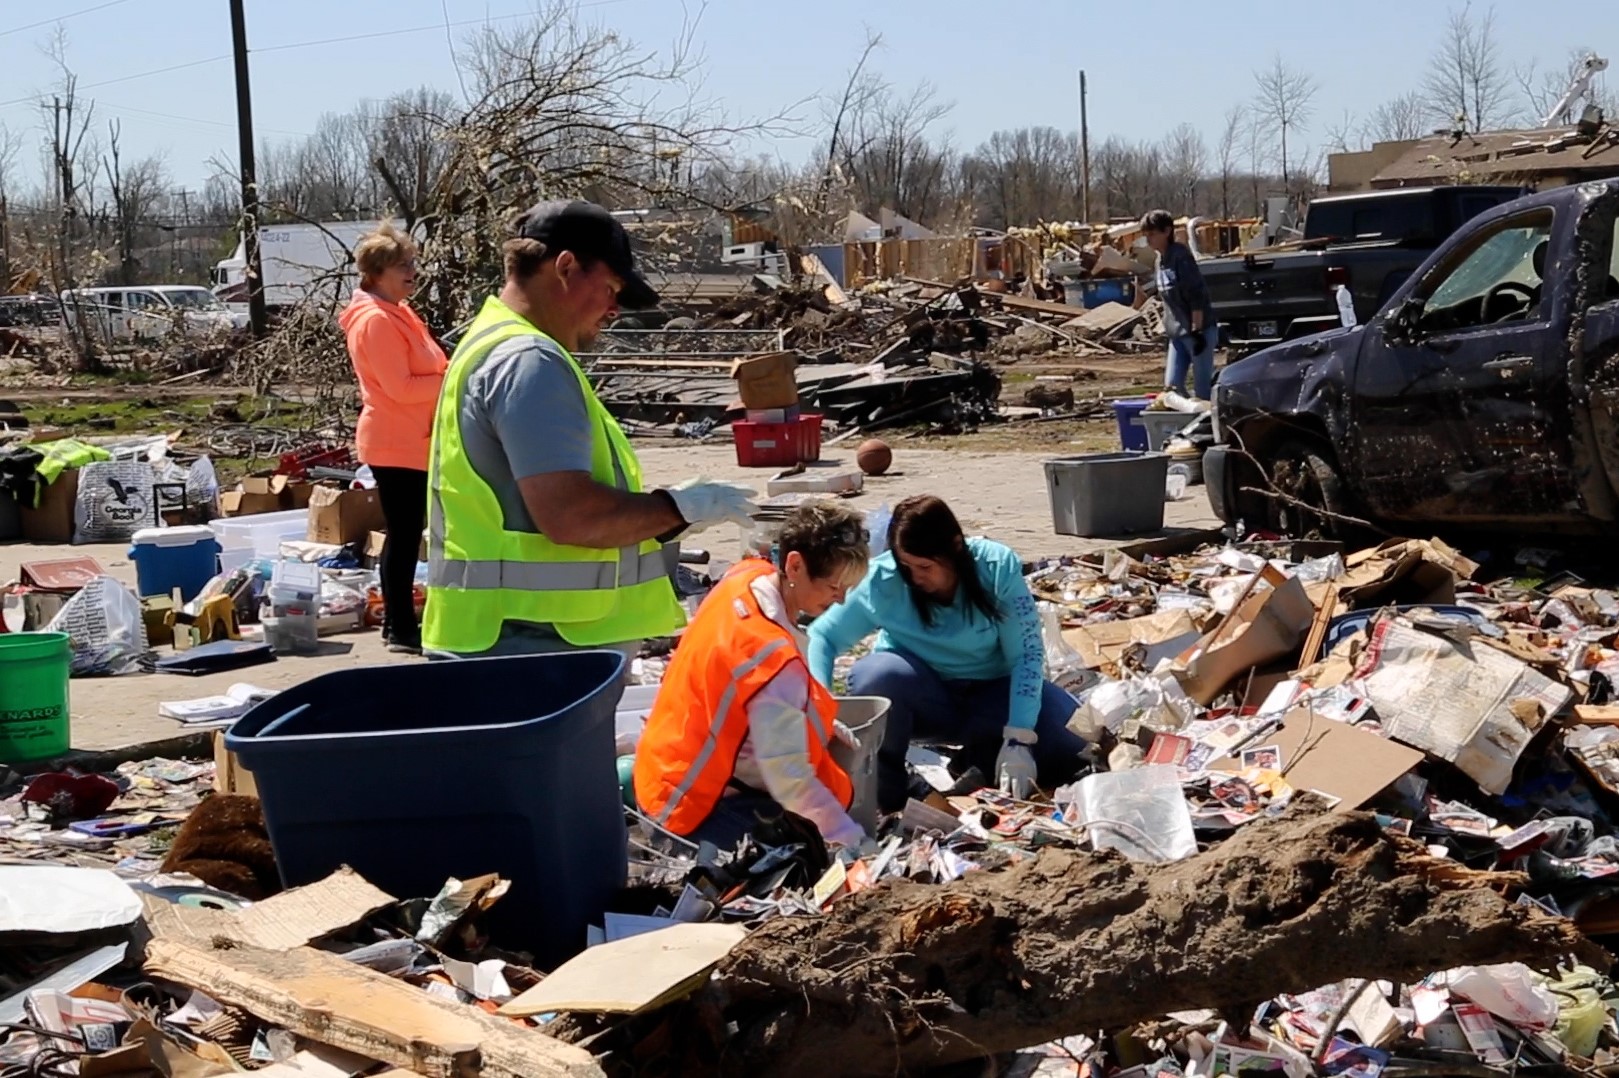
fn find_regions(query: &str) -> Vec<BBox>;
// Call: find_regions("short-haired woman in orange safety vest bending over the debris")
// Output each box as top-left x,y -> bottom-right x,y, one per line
635,502 -> 871,850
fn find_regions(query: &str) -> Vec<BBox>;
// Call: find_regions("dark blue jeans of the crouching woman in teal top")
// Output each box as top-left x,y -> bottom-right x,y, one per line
848,651 -> 1086,813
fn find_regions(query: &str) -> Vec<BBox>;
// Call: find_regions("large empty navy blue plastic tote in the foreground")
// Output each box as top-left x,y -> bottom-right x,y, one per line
225,651 -> 628,970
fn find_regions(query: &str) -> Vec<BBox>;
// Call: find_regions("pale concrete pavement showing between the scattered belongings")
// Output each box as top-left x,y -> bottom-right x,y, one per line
0,444 -> 1217,751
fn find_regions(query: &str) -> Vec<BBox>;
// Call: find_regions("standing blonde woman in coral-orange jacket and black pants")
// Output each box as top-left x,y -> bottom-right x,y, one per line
338,223 -> 448,654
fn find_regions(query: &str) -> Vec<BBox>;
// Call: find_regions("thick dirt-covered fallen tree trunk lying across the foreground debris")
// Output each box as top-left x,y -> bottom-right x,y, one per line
704,804 -> 1608,1078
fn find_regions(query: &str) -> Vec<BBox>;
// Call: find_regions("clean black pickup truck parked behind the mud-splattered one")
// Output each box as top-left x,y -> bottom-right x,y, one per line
1200,186 -> 1527,356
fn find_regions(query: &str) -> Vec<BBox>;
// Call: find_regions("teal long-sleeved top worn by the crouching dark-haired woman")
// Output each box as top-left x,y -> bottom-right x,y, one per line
810,539 -> 1046,730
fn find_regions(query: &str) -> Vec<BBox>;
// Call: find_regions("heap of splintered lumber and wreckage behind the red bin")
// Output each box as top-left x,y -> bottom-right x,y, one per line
584,278 -> 1162,435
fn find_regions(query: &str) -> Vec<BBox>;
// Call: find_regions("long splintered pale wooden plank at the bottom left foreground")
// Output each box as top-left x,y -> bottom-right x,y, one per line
146,939 -> 604,1078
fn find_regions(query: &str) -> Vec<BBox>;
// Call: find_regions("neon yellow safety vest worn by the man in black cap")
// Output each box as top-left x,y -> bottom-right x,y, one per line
421,289 -> 685,654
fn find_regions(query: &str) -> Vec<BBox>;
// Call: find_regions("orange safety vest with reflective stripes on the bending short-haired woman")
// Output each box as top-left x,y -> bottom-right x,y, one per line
635,558 -> 855,835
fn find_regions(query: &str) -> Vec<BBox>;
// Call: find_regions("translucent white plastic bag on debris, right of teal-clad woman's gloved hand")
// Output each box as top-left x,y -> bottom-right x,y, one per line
1052,764 -> 1198,861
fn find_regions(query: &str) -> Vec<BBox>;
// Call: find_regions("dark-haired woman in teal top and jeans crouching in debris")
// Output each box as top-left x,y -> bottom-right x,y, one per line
810,495 -> 1085,813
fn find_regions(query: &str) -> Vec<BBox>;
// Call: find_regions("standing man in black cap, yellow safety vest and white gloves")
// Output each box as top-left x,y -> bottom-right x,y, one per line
423,202 -> 754,657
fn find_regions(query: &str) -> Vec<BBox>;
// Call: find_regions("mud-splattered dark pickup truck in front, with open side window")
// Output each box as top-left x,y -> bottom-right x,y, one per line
1203,180 -> 1619,534
